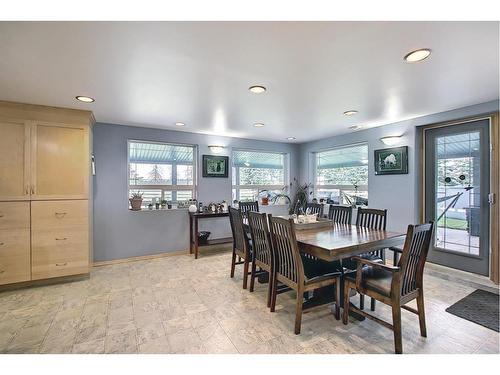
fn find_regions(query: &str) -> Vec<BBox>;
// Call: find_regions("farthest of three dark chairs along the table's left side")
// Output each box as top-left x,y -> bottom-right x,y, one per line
229,207 -> 251,289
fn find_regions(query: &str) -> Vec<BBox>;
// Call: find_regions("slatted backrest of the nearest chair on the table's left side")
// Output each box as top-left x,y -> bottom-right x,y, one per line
269,215 -> 304,284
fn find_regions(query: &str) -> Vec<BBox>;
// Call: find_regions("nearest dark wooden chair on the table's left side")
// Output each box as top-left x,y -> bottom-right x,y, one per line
269,216 -> 341,335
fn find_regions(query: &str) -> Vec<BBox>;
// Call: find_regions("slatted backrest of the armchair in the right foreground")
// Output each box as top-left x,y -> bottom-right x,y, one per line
398,222 -> 434,296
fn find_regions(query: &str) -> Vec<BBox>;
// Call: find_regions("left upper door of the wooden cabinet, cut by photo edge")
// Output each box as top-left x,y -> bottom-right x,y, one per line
0,120 -> 30,201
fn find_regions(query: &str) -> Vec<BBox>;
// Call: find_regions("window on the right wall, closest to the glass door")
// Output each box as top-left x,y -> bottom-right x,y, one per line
313,143 -> 368,205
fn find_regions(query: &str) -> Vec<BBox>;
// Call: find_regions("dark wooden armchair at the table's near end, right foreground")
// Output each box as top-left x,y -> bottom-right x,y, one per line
342,222 -> 434,354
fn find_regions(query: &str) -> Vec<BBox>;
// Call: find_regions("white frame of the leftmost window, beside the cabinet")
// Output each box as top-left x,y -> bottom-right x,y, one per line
127,139 -> 198,203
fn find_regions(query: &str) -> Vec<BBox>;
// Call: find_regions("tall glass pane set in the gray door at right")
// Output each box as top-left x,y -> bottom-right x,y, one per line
435,132 -> 481,256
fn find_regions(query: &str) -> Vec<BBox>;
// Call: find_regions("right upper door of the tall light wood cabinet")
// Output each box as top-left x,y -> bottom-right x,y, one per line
30,122 -> 90,200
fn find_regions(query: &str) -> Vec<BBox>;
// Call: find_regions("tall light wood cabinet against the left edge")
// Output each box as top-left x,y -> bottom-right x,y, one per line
0,102 -> 94,285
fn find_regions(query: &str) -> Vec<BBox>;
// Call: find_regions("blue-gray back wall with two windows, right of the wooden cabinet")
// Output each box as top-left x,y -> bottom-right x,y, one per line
93,123 -> 299,261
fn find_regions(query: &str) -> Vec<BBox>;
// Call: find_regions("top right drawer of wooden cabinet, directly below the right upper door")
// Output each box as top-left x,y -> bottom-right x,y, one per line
31,200 -> 89,230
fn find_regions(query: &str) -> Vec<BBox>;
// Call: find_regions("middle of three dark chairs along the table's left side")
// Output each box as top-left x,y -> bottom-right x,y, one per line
248,211 -> 274,307
